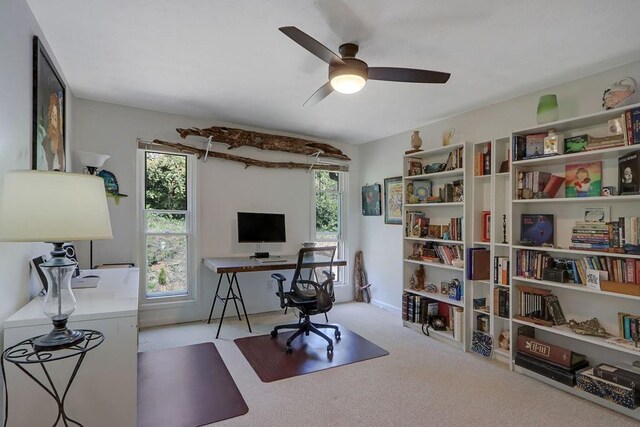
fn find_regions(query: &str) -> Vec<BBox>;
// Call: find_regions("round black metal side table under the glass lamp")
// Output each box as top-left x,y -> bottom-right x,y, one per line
0,329 -> 104,427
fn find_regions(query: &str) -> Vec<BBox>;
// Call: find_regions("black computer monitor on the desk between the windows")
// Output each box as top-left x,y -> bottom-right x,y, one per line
238,212 -> 287,256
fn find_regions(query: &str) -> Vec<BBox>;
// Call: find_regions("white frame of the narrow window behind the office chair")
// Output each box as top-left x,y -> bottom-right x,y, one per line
309,169 -> 349,286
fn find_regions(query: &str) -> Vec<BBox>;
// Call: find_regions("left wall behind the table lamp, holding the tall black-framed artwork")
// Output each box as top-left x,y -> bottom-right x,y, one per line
0,0 -> 72,421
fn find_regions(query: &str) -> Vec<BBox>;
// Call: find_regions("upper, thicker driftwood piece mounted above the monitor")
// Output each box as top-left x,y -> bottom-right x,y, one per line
176,126 -> 351,160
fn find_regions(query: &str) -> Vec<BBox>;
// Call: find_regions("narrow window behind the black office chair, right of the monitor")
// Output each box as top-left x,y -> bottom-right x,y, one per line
311,170 -> 346,282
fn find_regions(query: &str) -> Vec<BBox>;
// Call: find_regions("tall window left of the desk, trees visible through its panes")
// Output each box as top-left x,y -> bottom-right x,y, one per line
141,150 -> 194,298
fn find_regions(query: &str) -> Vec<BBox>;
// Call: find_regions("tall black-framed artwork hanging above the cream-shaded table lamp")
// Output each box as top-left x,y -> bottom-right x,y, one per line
31,36 -> 66,171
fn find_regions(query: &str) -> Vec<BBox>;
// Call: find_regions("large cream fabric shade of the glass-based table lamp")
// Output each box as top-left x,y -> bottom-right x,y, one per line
0,171 -> 113,242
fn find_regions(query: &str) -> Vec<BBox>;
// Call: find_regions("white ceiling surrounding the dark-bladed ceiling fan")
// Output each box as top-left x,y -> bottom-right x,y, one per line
27,0 -> 640,144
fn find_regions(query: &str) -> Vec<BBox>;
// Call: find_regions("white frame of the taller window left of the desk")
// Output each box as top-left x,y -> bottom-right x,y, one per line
136,148 -> 198,309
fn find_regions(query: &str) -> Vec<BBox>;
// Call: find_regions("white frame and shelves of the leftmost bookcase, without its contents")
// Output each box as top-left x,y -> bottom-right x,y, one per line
402,144 -> 470,350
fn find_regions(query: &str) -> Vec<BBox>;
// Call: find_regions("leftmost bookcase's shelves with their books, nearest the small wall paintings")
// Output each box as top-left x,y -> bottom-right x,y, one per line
402,143 -> 470,348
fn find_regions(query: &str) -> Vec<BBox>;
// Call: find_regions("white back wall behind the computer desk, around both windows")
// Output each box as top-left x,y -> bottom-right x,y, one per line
74,99 -> 360,326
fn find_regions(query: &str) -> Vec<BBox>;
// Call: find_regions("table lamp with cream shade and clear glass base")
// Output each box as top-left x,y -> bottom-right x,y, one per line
0,171 -> 113,351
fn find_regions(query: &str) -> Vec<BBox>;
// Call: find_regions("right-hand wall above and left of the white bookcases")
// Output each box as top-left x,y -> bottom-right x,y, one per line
360,62 -> 640,313
